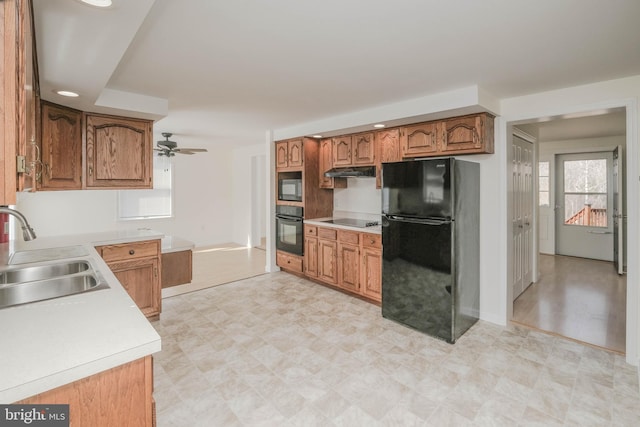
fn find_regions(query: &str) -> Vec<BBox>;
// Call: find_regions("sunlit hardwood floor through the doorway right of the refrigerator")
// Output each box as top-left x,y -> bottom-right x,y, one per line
512,254 -> 627,354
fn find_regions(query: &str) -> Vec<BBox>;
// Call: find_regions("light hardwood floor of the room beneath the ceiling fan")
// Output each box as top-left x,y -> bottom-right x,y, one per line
162,243 -> 266,298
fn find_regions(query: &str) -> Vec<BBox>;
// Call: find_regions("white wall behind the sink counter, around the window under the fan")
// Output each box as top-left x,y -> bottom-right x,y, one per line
16,147 -> 234,246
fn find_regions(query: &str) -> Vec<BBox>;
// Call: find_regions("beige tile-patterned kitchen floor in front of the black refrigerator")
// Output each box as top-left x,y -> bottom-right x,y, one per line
153,272 -> 640,427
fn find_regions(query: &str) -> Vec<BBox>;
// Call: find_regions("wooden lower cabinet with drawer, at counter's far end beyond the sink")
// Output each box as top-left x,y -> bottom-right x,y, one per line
96,240 -> 162,319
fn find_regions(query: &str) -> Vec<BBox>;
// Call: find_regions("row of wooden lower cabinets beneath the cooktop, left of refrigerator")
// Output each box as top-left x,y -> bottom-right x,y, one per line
304,225 -> 382,302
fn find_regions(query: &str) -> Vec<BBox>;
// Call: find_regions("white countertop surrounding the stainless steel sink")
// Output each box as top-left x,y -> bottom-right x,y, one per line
0,230 -> 163,403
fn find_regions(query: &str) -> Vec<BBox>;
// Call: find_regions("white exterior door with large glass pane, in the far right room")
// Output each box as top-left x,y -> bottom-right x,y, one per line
555,152 -> 613,261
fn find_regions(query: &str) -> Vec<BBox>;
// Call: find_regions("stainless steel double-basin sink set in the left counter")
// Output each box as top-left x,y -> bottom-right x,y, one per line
0,246 -> 109,309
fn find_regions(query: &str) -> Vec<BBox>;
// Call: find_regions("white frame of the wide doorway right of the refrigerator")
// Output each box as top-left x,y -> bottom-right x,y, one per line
496,98 -> 640,366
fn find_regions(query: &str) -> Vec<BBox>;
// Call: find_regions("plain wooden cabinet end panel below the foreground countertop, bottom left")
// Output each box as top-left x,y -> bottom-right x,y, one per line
16,356 -> 155,427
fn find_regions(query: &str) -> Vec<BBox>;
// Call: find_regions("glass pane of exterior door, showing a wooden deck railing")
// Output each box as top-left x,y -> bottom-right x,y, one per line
563,159 -> 607,227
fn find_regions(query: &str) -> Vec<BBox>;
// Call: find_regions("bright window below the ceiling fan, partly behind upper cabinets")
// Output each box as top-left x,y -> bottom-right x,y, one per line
118,156 -> 173,220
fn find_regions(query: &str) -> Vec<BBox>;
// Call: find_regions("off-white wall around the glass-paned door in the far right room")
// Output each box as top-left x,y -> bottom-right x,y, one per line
538,136 -> 626,254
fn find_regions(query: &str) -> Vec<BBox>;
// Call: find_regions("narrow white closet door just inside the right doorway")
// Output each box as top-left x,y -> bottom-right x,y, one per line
511,135 -> 534,300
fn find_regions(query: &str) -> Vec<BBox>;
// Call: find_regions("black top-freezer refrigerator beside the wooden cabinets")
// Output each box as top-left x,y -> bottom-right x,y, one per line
382,157 -> 480,343
